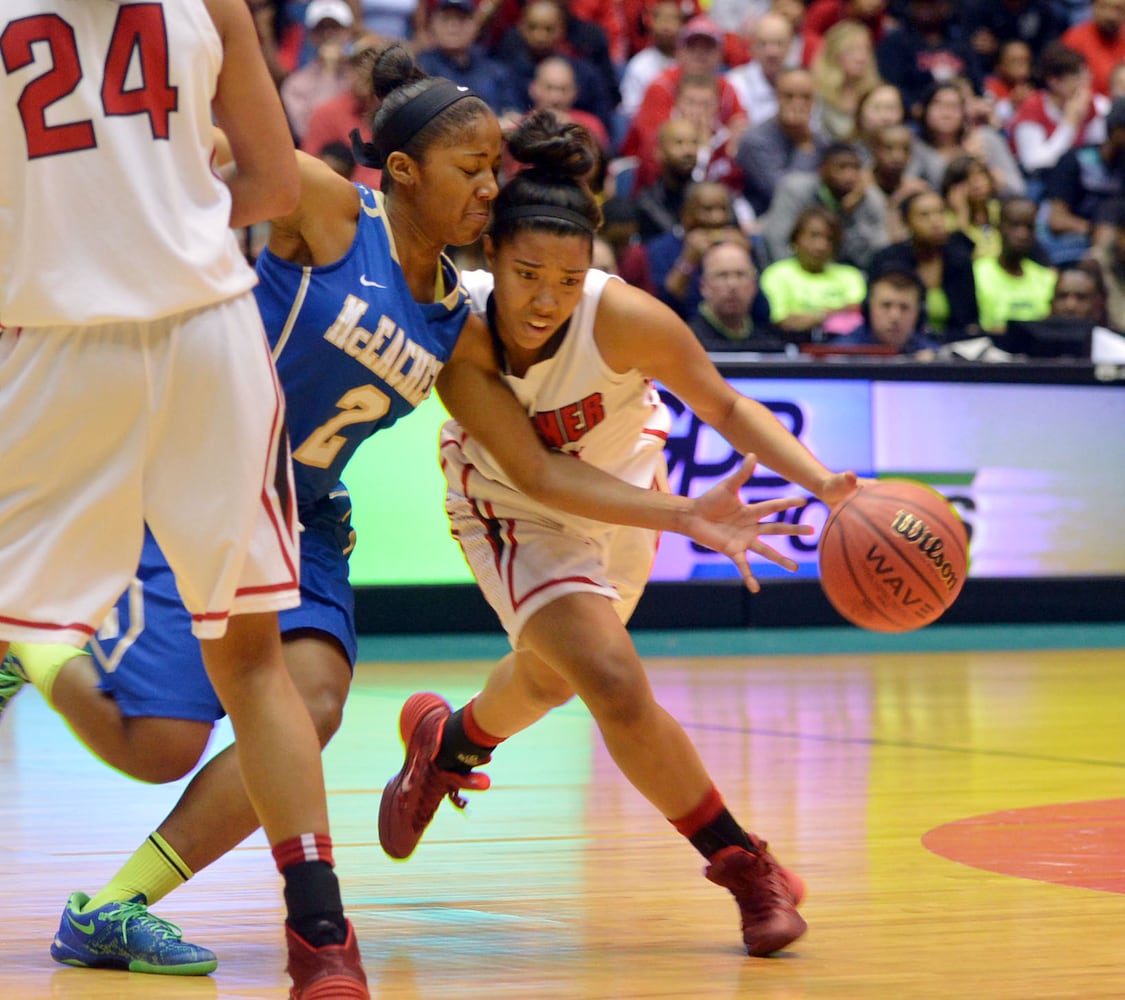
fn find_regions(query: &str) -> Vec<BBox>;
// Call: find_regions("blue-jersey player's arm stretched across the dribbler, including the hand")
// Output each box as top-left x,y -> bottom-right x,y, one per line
437,316 -> 811,591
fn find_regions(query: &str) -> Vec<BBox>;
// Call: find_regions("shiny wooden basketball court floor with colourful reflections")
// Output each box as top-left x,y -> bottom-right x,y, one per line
0,625 -> 1125,1000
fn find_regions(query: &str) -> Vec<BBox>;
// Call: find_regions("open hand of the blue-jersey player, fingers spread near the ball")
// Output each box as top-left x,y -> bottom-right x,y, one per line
683,454 -> 814,594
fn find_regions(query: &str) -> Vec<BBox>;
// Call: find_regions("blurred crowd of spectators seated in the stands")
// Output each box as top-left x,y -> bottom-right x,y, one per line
250,0 -> 1125,357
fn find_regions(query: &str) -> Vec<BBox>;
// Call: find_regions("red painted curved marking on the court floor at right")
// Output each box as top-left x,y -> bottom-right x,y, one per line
921,799 -> 1125,893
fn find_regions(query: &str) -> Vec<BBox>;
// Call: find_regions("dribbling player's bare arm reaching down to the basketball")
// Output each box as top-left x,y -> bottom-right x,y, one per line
596,281 -> 856,504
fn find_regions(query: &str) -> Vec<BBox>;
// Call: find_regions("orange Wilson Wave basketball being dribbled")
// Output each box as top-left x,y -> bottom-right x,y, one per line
819,479 -> 969,632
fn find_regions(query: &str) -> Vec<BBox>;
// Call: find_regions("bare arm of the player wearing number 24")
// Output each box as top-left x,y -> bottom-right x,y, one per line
204,0 -> 298,228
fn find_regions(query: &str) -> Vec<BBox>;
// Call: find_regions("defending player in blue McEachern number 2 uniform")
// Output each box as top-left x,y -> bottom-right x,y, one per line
0,47 -> 810,972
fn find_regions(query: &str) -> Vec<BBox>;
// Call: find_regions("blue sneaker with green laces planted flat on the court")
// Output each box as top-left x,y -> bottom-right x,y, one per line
51,892 -> 218,975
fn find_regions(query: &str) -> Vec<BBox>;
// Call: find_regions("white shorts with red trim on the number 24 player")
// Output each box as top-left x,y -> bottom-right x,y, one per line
0,292 -> 299,646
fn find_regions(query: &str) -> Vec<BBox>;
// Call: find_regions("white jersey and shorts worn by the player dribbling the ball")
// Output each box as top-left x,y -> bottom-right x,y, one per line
441,270 -> 672,636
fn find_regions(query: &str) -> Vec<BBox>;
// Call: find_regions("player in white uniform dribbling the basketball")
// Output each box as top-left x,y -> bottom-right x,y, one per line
379,112 -> 857,955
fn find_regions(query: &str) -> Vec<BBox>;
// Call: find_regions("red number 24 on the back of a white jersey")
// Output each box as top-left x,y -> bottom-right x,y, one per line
0,3 -> 178,160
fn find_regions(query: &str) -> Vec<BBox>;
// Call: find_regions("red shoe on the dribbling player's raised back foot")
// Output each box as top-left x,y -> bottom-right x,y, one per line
379,694 -> 491,861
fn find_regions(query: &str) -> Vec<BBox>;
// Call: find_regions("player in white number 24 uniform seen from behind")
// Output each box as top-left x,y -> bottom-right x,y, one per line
0,0 -> 368,1000
